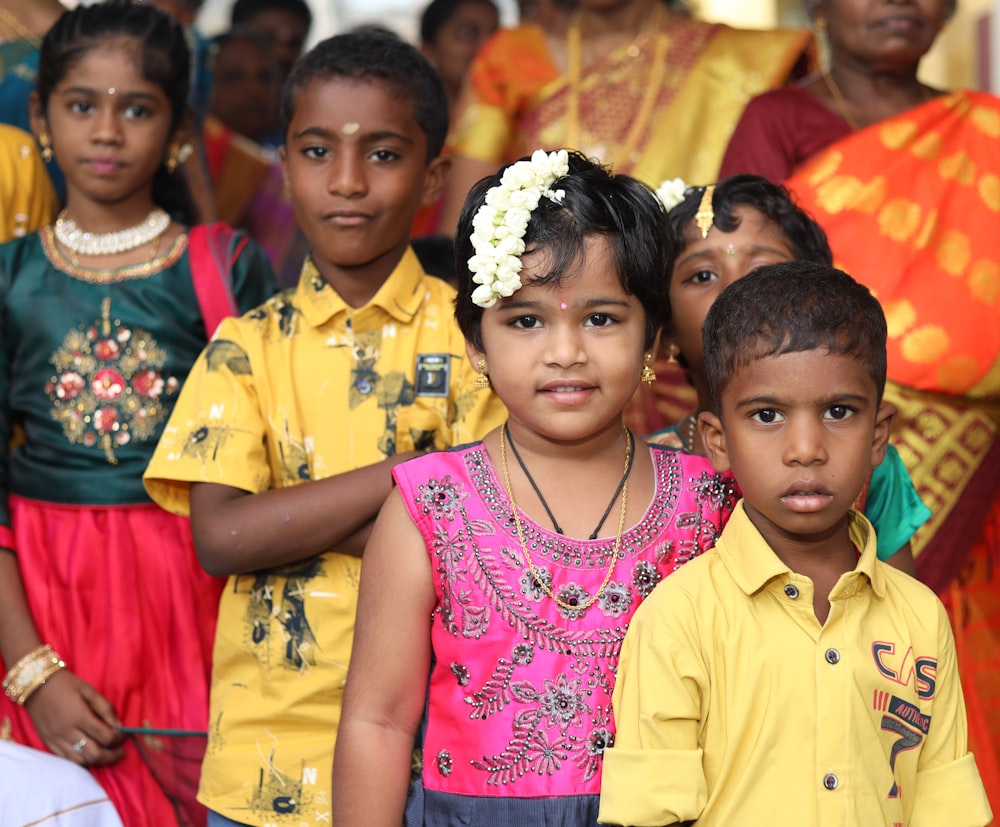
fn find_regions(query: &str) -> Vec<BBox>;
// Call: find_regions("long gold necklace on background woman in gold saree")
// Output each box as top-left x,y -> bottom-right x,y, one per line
566,0 -> 669,166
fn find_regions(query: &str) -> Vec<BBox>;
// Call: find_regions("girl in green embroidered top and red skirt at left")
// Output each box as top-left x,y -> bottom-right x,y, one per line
0,1 -> 273,827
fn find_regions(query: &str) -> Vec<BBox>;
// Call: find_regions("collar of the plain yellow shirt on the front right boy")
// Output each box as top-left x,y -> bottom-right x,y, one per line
716,500 -> 885,597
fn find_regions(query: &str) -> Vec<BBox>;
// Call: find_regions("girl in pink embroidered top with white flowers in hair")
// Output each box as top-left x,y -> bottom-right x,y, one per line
333,152 -> 734,827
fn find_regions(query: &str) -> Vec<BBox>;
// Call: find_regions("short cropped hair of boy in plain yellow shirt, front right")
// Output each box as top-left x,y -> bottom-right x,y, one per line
701,261 -> 886,417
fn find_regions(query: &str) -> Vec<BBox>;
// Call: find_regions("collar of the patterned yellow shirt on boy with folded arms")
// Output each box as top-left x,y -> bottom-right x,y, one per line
295,247 -> 427,327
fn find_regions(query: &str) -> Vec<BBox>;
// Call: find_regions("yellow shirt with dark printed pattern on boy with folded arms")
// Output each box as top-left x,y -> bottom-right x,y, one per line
145,251 -> 504,827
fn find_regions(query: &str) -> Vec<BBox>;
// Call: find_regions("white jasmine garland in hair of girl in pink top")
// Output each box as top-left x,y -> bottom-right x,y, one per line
469,149 -> 569,308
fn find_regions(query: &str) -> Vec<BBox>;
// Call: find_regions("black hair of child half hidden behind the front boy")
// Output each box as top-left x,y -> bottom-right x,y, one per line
670,175 -> 833,270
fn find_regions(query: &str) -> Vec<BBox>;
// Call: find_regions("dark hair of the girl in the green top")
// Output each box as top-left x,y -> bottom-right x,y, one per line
35,0 -> 195,223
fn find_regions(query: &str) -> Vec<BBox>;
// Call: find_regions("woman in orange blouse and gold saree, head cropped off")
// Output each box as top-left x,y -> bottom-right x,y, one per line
442,0 -> 811,236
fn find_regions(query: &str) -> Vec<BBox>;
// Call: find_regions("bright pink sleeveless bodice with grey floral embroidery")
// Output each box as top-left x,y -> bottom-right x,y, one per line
409,446 -> 735,795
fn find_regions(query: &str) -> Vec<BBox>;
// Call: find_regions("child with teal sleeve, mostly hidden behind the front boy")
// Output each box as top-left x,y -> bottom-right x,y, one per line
646,175 -> 930,574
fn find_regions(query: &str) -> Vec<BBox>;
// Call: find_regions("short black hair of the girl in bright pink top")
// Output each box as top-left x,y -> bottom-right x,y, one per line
455,152 -> 675,350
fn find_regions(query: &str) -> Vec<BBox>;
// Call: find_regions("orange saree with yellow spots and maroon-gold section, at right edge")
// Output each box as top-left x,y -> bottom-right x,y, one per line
786,91 -> 1000,811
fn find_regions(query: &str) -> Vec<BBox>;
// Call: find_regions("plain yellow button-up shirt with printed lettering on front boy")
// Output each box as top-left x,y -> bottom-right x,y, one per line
599,503 -> 991,827
